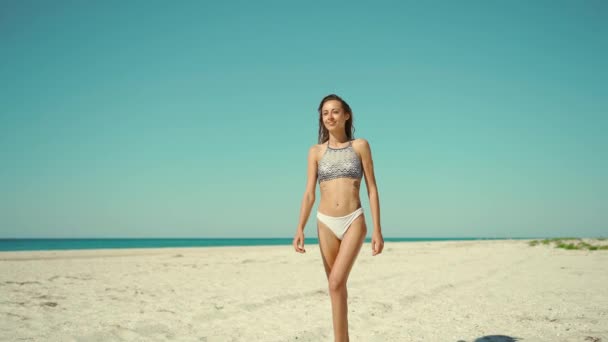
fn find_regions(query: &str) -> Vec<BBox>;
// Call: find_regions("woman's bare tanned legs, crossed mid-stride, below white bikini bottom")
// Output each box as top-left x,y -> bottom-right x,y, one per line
318,215 -> 367,342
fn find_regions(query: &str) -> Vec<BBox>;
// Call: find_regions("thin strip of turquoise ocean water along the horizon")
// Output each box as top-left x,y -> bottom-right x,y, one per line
0,237 -> 521,251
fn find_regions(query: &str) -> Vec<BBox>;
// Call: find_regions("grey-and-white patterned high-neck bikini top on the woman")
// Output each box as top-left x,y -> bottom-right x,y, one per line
317,140 -> 363,183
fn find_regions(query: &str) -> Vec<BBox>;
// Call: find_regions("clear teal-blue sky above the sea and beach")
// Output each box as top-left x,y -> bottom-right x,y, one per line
0,0 -> 608,237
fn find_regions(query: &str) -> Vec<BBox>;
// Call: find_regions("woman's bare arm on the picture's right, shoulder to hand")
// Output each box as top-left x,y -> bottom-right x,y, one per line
357,139 -> 384,255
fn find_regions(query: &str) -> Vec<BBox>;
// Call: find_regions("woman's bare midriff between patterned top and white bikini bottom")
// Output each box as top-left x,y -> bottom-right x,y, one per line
318,178 -> 361,217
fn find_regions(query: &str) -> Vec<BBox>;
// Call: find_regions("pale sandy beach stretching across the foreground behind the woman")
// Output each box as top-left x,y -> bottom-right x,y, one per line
0,240 -> 608,342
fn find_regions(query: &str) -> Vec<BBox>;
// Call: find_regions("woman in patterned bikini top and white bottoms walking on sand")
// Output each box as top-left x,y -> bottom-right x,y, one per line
293,94 -> 384,341
